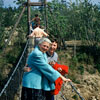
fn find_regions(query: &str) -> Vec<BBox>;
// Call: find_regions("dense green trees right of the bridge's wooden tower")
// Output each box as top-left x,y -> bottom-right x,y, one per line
47,0 -> 100,45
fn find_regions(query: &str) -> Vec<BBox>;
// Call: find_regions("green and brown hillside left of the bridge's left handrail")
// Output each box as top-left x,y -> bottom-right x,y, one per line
0,4 -> 27,89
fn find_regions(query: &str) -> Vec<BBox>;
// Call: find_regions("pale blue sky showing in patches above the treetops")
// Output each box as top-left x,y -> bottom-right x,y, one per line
3,0 -> 100,7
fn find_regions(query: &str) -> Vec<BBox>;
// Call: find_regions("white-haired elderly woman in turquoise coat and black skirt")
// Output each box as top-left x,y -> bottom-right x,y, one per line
21,38 -> 70,100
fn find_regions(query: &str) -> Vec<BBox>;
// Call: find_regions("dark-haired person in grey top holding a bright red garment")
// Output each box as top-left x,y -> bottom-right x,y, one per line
46,40 -> 68,100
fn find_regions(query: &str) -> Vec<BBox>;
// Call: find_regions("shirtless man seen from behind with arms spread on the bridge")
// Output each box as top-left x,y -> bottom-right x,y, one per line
28,26 -> 49,47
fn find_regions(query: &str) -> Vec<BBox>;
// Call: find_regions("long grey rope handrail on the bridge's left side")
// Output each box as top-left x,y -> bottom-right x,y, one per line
0,41 -> 29,97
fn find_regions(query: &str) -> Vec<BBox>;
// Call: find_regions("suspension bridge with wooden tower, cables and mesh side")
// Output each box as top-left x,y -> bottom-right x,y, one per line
0,0 -> 84,100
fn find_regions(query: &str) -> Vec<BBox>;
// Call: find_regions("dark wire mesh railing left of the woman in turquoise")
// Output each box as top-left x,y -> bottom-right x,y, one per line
0,41 -> 29,100
